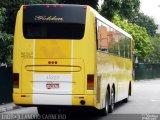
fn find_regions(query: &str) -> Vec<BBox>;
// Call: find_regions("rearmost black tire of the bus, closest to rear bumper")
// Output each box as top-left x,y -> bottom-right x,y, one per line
99,92 -> 109,116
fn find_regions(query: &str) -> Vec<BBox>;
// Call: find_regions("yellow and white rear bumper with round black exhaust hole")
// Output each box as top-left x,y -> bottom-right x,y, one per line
13,94 -> 96,107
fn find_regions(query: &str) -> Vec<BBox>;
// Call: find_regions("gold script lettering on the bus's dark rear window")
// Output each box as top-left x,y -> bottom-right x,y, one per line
34,16 -> 63,21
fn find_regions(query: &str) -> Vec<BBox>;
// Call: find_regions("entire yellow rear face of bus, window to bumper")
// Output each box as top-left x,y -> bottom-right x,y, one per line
13,4 -> 96,109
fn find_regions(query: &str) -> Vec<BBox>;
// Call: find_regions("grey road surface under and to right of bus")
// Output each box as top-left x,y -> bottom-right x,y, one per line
0,79 -> 160,120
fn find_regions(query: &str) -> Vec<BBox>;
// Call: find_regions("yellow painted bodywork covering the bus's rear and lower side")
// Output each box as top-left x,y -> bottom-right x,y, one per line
13,6 -> 132,109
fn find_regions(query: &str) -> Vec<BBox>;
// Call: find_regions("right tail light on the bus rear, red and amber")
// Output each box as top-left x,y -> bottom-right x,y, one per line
87,75 -> 94,90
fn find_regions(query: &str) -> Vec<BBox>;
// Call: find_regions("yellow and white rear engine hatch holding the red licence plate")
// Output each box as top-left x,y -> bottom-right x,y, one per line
22,59 -> 84,94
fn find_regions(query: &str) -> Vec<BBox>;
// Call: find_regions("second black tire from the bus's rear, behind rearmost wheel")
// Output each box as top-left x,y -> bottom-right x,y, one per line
109,88 -> 115,113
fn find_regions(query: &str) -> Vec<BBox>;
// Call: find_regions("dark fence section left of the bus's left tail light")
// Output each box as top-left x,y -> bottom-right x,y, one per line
0,67 -> 13,104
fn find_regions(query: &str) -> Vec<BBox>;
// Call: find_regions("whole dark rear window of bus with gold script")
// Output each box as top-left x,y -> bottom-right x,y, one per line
23,5 -> 86,39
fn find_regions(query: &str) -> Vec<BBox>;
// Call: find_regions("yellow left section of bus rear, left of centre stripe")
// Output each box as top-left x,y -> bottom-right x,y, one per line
13,7 -> 33,104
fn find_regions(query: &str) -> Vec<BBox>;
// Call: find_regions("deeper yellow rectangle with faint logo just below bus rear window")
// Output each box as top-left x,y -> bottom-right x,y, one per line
35,39 -> 71,58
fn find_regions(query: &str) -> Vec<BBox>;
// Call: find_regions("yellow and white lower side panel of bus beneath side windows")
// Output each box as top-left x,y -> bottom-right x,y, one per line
97,52 -> 132,108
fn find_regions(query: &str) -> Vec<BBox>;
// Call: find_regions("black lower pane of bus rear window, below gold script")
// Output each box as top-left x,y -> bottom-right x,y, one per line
23,23 -> 85,39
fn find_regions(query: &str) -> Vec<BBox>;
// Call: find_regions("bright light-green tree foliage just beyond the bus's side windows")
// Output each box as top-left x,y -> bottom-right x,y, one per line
112,16 -> 153,61
